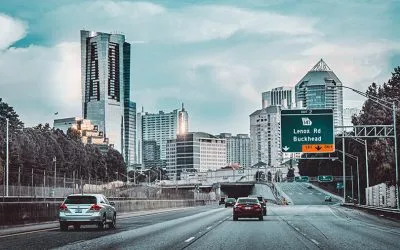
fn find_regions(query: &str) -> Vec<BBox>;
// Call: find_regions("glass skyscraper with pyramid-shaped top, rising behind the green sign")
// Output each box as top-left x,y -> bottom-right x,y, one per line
295,59 -> 343,126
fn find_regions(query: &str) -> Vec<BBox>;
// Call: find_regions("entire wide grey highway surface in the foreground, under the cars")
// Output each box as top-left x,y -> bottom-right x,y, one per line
0,198 -> 400,250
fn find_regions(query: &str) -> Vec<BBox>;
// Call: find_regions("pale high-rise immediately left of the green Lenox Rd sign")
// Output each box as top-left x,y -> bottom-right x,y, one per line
250,106 -> 282,168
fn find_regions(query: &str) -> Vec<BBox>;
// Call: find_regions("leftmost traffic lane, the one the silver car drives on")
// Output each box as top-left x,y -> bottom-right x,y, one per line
0,205 -> 217,249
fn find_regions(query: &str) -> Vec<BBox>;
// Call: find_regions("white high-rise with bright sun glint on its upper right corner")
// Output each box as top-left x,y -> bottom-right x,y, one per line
137,104 -> 189,166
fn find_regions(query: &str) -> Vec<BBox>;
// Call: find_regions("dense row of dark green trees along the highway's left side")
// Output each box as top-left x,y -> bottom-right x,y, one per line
0,98 -> 126,185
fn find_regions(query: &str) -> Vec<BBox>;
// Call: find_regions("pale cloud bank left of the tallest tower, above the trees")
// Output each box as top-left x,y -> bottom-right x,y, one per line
0,43 -> 81,125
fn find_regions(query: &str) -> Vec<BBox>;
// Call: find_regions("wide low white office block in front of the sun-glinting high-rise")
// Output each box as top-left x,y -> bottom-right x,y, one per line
166,132 -> 227,179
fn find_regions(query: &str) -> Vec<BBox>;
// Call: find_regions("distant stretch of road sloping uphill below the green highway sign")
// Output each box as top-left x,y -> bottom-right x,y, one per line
276,182 -> 340,205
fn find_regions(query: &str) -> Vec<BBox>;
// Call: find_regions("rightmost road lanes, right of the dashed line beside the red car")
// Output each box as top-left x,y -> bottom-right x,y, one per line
272,206 -> 400,249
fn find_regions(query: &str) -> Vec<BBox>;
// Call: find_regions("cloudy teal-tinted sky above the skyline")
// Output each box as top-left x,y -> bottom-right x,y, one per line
0,0 -> 400,134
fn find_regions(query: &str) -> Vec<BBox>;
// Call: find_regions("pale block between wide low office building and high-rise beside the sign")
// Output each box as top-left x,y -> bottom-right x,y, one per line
217,133 -> 251,168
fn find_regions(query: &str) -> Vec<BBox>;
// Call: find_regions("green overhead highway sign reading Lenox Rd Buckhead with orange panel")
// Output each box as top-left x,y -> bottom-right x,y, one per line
281,109 -> 335,153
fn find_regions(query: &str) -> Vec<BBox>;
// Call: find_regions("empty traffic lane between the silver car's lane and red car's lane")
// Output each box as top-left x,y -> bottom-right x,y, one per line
59,208 -> 232,249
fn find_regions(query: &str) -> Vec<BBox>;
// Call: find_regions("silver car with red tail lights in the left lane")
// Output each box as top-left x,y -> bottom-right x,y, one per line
58,194 -> 117,231
